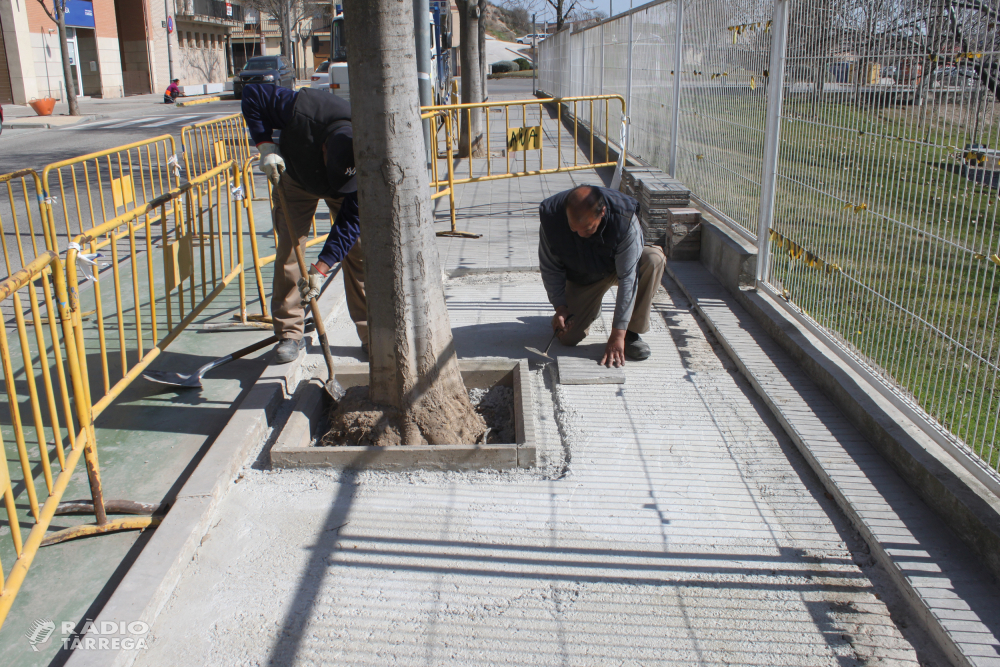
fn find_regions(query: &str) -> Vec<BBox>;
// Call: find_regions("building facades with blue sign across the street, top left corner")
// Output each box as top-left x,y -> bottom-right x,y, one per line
0,0 -> 244,104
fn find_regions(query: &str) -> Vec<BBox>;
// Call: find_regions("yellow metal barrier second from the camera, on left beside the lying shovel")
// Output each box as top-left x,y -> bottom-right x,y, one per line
66,161 -> 245,418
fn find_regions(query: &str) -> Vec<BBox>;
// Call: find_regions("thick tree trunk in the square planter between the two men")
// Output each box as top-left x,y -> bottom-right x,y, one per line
344,0 -> 486,445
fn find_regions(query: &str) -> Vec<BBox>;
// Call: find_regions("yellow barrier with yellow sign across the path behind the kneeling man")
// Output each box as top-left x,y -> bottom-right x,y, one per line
421,95 -> 626,237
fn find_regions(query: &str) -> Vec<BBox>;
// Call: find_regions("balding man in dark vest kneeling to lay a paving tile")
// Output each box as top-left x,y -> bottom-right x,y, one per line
538,185 -> 667,367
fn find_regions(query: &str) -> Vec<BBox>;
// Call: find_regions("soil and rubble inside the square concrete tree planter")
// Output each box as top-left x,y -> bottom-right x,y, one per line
316,385 -> 515,447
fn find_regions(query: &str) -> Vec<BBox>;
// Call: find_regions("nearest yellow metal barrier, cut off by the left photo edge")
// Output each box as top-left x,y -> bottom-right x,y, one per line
0,251 -> 159,626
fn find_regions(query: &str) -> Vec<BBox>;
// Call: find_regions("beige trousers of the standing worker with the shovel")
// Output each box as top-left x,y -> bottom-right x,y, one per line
271,173 -> 368,343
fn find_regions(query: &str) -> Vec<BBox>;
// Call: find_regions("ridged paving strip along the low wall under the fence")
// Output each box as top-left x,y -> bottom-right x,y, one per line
668,262 -> 1000,666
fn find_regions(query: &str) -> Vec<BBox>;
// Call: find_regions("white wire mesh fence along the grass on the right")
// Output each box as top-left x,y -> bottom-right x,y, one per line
539,0 -> 1000,470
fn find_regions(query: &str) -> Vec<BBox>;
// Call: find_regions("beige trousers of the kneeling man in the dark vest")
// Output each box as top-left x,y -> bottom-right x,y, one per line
559,246 -> 667,345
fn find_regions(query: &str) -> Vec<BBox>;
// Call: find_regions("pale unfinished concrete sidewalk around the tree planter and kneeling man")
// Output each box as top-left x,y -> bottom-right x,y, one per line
125,124 -> 943,665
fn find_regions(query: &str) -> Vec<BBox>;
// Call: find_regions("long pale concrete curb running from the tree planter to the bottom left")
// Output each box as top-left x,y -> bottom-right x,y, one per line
65,266 -> 346,667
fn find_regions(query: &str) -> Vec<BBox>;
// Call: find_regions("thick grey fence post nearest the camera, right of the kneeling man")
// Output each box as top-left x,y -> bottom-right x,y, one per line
757,0 -> 790,284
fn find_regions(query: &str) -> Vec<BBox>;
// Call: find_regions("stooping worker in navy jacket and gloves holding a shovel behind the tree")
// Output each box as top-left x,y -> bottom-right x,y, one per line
242,83 -> 368,363
